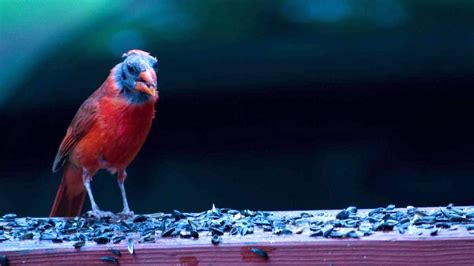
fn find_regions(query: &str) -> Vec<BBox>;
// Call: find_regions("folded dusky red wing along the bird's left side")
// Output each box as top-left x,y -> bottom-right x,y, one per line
53,94 -> 98,172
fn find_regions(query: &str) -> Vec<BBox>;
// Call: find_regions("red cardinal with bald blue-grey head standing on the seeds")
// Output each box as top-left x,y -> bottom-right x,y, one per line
50,50 -> 158,217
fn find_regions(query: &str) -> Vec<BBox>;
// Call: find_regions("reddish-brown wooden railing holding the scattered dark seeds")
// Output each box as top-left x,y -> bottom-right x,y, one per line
0,208 -> 474,265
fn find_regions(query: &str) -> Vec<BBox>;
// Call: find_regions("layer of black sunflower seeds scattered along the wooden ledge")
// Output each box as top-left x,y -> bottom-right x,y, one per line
0,204 -> 474,246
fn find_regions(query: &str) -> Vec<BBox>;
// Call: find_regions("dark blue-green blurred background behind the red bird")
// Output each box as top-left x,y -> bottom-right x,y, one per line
0,0 -> 474,216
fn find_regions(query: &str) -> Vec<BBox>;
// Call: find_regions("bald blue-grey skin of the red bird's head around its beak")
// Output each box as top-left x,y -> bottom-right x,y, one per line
115,52 -> 158,103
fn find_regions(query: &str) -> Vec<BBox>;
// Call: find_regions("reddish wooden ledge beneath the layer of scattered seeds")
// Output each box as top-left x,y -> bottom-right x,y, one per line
0,208 -> 474,265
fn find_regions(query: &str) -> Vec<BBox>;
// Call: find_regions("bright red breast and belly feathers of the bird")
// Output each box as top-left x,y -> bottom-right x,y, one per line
70,92 -> 155,173
